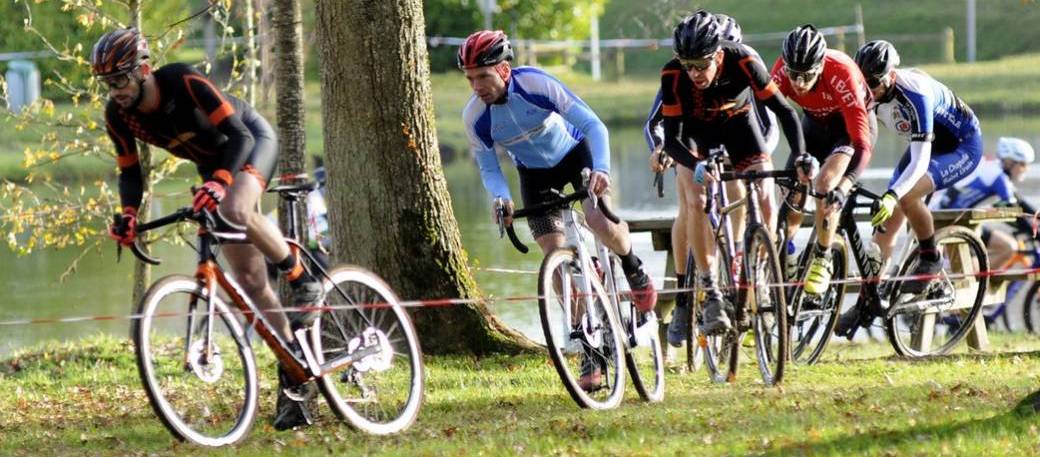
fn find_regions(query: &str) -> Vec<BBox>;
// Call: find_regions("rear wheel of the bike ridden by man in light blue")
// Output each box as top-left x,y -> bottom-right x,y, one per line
610,255 -> 665,402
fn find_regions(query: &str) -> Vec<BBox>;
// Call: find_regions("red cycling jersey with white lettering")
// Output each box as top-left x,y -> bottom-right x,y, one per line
772,49 -> 873,175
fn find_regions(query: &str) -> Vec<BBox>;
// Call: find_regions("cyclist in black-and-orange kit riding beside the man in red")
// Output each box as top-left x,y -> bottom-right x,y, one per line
660,10 -> 805,334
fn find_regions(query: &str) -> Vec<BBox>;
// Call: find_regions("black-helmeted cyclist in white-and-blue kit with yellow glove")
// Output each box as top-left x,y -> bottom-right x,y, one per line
835,40 -> 983,334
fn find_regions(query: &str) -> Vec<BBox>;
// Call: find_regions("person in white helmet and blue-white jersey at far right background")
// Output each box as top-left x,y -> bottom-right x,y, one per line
933,136 -> 1037,269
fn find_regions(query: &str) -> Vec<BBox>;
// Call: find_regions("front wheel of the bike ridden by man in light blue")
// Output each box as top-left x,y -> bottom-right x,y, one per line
538,248 -> 625,409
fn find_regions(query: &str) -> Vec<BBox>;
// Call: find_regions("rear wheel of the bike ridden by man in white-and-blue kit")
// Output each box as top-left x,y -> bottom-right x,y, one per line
885,226 -> 989,358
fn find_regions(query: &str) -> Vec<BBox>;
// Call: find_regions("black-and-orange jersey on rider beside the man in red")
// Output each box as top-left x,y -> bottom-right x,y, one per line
660,42 -> 805,167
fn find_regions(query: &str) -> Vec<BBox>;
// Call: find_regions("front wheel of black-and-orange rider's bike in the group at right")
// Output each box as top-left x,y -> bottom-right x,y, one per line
738,225 -> 789,385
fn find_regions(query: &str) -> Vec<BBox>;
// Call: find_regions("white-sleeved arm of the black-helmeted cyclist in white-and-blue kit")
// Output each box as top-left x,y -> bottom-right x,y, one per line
888,87 -> 935,198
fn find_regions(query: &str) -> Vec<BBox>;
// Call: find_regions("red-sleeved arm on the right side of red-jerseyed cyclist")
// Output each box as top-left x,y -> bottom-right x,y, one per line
828,67 -> 874,180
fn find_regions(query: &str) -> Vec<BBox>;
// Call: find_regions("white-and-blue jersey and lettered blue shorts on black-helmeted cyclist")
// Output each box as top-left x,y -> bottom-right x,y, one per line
876,69 -> 982,197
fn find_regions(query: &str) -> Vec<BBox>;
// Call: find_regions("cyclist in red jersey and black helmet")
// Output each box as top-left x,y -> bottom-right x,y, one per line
772,24 -> 878,296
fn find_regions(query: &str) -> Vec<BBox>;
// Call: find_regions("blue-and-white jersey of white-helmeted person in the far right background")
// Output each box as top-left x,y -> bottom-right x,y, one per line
936,159 -> 1018,209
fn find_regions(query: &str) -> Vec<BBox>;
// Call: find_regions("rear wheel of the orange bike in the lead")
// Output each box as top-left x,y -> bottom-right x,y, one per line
310,265 -> 424,435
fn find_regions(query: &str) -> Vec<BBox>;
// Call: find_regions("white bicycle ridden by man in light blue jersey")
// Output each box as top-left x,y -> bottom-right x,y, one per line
498,170 -> 665,409
